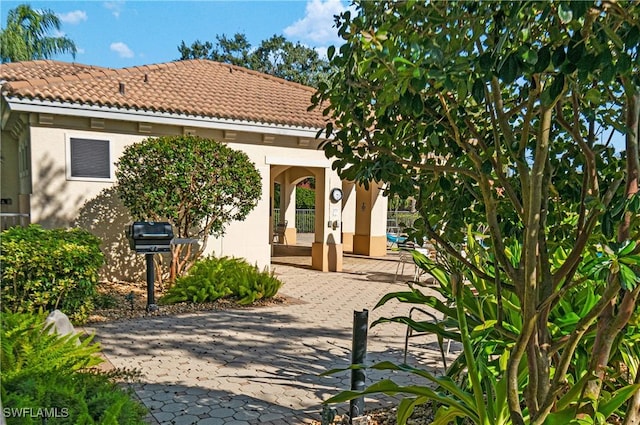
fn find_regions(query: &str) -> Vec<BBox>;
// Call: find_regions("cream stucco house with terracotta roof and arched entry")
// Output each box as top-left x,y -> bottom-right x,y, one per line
0,60 -> 387,277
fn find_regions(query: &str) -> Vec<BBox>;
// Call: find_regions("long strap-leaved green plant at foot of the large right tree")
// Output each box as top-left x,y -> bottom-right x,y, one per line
327,238 -> 640,424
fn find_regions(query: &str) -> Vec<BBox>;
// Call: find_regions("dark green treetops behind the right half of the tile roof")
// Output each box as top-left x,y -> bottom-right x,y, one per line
178,33 -> 328,87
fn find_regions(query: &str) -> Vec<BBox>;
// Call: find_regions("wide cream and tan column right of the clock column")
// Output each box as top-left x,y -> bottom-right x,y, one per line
353,182 -> 388,257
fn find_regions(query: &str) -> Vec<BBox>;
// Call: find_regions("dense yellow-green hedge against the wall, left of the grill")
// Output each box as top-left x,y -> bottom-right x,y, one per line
0,225 -> 104,322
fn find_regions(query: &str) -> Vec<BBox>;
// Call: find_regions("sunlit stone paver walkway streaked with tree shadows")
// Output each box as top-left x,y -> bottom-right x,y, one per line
86,250 -> 452,425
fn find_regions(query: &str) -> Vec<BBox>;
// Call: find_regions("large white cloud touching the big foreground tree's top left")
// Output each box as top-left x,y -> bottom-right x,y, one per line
284,0 -> 347,45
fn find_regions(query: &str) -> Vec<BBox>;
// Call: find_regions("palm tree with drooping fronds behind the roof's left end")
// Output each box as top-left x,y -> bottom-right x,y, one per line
0,4 -> 77,63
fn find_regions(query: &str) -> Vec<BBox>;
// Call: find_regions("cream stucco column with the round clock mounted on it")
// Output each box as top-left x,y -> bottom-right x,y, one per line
311,168 -> 342,272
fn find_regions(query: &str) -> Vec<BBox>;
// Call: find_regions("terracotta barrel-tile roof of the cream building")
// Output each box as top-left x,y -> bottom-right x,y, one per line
0,60 -> 325,128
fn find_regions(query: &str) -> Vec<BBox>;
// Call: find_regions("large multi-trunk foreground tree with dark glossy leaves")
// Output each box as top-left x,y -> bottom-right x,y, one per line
314,1 -> 640,424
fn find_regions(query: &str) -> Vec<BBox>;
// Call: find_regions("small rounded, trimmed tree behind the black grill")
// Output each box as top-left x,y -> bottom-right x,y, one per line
116,136 -> 262,282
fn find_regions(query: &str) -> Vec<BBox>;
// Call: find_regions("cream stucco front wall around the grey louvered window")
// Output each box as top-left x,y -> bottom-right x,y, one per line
25,121 -> 332,280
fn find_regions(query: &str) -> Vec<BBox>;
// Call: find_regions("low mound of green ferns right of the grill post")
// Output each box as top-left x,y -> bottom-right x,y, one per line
160,257 -> 282,305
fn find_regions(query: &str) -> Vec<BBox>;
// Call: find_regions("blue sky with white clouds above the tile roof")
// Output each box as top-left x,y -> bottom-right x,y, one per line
0,0 -> 347,68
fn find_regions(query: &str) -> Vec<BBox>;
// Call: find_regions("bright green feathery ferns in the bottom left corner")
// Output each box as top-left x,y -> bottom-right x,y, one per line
0,313 -> 146,424
